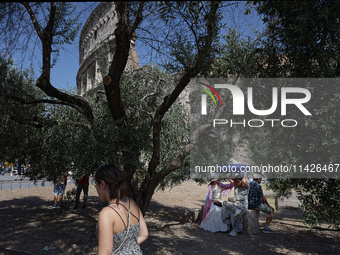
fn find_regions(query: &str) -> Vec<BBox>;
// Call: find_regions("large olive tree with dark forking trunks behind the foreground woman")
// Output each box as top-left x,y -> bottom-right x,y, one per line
0,1 -> 228,213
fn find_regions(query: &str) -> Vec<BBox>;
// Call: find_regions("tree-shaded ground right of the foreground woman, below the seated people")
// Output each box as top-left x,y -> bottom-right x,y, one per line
142,202 -> 339,255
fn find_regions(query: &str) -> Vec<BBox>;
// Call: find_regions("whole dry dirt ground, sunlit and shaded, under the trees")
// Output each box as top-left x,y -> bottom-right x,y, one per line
0,181 -> 340,255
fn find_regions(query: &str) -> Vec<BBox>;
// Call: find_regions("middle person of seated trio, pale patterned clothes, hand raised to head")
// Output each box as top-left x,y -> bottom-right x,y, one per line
222,175 -> 249,236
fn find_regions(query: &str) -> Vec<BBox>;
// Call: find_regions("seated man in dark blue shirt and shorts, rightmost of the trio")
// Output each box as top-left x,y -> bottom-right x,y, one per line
248,174 -> 275,233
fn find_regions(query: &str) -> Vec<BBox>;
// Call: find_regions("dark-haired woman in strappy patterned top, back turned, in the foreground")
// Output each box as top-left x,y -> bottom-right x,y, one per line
95,164 -> 148,255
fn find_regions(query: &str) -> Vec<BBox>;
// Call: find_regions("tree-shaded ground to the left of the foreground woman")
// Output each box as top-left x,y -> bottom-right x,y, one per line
0,196 -> 100,254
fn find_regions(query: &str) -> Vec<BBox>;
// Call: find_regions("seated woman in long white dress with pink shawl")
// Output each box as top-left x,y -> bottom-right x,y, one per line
200,178 -> 233,232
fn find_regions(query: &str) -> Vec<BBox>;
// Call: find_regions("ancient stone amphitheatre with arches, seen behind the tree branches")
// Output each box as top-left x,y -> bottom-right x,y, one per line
77,2 -> 139,95
